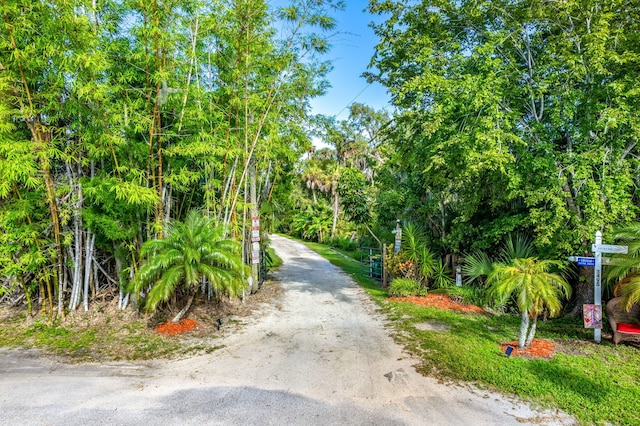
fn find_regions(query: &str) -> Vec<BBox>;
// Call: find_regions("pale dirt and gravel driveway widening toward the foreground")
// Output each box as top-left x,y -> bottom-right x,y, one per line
0,236 -> 573,425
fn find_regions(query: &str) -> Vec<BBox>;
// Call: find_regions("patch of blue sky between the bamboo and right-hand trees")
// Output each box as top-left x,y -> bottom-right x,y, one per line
311,0 -> 390,120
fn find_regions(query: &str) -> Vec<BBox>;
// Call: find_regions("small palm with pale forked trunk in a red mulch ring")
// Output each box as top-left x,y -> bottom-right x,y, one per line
487,257 -> 571,348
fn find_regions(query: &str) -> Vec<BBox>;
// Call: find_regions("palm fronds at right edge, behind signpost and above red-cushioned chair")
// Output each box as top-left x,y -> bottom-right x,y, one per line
605,223 -> 640,311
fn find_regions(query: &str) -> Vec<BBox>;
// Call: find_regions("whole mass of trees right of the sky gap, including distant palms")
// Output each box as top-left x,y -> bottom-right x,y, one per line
290,0 -> 640,313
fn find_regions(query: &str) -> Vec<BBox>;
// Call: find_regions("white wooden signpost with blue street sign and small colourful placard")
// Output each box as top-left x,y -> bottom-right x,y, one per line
569,231 -> 629,343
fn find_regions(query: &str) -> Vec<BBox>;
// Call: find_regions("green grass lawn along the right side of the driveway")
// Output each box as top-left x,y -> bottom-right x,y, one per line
306,243 -> 640,425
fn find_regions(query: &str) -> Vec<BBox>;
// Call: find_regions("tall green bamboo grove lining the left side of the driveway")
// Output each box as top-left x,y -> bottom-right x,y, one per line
0,0 -> 342,318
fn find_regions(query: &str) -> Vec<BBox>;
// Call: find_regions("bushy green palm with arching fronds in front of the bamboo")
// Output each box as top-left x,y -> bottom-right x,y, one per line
132,210 -> 250,322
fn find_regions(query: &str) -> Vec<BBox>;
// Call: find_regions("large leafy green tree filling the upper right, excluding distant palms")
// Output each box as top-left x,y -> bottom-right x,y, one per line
368,0 -> 639,304
